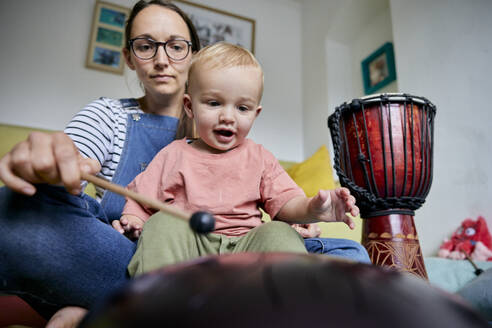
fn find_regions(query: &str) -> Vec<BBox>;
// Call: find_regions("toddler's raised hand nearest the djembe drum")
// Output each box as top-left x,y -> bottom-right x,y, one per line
309,188 -> 359,229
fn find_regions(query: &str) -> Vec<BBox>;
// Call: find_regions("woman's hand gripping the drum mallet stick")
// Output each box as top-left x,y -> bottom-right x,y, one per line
0,132 -> 100,195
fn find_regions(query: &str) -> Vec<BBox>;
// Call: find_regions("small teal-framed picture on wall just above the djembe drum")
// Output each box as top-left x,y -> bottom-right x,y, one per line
362,42 -> 396,95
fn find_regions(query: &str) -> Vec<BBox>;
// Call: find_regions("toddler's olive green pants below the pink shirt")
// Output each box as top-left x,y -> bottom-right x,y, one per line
128,213 -> 307,276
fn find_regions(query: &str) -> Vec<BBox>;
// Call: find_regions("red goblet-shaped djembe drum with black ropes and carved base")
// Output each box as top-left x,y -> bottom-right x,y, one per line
328,94 -> 436,279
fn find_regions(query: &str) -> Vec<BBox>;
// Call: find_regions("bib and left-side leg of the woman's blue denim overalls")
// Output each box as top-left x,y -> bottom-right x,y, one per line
0,99 -> 178,317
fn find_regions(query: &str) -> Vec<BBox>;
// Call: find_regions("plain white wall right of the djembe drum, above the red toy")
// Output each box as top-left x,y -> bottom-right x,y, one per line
391,0 -> 492,254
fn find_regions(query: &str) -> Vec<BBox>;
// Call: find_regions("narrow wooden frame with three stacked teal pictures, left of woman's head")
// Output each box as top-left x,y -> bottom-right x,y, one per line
86,1 -> 130,74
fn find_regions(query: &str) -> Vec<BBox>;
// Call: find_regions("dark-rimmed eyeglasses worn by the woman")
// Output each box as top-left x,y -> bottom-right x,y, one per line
128,38 -> 192,61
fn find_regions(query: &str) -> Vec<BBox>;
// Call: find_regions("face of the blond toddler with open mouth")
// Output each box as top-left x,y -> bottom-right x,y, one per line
185,66 -> 262,153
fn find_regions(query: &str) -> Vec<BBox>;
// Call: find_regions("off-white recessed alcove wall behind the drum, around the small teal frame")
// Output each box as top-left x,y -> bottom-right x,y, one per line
300,0 -> 397,157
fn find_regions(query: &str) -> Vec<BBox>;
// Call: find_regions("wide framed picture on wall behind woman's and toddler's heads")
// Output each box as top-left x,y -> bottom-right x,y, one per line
174,0 -> 255,53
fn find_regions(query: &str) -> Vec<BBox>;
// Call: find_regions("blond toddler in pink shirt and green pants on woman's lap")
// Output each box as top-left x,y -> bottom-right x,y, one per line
118,43 -> 359,276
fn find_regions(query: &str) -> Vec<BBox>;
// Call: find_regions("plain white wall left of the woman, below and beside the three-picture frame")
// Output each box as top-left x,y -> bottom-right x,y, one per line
0,0 -> 142,129
